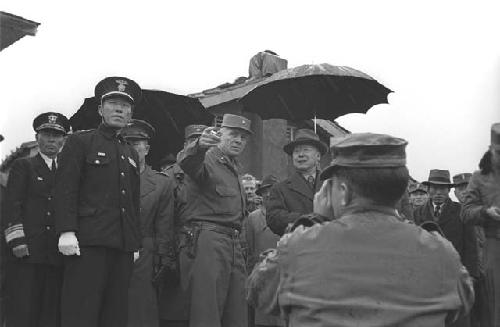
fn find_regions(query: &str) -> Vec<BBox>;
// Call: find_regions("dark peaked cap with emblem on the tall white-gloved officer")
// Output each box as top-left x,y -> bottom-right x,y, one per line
94,77 -> 142,104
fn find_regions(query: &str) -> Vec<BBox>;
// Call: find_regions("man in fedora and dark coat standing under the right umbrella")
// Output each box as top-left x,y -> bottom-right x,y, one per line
267,129 -> 328,236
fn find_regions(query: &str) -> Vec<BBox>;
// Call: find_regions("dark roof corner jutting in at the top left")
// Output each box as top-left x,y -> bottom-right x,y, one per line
0,11 -> 40,51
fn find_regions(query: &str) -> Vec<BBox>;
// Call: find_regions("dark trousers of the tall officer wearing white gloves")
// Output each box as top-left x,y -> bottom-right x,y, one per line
61,247 -> 134,327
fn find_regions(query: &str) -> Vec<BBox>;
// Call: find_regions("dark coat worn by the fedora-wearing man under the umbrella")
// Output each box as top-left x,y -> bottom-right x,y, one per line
266,172 -> 321,235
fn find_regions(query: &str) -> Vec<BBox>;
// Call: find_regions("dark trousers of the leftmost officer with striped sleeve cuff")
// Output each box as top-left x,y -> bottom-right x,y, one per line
5,259 -> 62,327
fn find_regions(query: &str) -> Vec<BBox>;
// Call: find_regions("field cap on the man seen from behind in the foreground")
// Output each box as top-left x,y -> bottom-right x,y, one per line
321,133 -> 408,180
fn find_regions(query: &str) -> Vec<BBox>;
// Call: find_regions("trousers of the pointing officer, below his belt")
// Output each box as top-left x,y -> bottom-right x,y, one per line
160,229 -> 247,327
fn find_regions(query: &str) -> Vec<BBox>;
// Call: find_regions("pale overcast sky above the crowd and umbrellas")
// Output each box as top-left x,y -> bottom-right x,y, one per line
0,0 -> 500,180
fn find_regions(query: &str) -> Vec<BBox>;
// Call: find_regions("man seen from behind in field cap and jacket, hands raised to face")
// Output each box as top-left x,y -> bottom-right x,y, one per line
248,133 -> 473,326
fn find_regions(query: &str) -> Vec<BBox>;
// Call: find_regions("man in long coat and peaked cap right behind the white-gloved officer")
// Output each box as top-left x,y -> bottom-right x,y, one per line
120,119 -> 175,327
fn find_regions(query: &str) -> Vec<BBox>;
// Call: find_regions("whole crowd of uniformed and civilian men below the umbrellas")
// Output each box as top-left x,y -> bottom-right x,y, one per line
2,73 -> 500,327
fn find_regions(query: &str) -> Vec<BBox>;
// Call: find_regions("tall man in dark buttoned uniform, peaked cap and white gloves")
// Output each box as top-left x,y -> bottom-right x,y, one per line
55,77 -> 142,327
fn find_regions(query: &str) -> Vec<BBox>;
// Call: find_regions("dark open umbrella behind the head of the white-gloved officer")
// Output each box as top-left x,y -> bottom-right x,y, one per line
70,90 -> 213,168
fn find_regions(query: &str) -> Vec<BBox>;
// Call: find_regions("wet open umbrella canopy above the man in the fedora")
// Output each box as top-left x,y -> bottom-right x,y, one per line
239,64 -> 392,121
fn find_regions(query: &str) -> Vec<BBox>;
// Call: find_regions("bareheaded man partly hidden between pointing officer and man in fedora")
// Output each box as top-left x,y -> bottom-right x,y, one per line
243,175 -> 284,327
